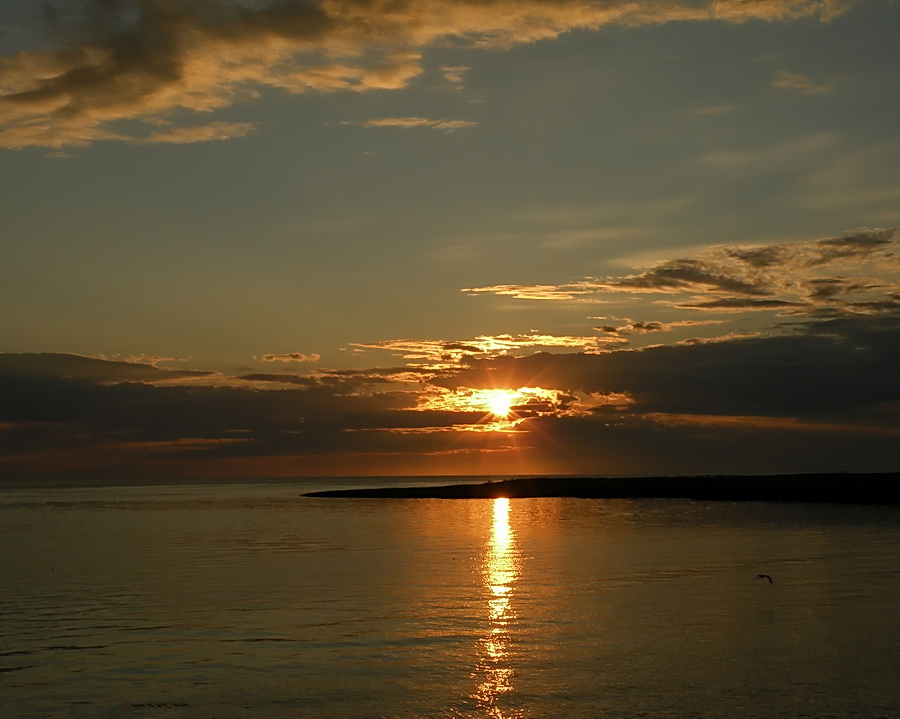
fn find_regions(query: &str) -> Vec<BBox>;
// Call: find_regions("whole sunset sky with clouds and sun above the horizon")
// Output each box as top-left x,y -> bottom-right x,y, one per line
0,0 -> 900,480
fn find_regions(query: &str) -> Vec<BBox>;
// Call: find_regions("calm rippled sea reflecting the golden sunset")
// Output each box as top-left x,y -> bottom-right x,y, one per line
0,478 -> 900,719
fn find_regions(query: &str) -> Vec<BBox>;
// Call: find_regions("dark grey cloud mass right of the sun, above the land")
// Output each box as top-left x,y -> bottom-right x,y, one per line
442,316 -> 900,422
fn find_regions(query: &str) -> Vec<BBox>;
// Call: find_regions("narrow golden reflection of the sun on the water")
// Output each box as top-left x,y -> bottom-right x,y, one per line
472,498 -> 524,719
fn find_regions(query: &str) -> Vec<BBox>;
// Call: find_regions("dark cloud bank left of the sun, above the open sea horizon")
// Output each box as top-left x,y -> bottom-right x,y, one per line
0,354 -> 516,474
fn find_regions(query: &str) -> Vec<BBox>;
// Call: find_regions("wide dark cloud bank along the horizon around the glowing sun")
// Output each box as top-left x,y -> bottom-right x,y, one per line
0,300 -> 900,478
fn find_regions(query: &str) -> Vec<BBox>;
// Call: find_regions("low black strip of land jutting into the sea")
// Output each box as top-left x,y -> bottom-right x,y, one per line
301,472 -> 900,506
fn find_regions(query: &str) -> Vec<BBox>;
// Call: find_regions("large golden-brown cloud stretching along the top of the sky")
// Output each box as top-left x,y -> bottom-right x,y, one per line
0,0 -> 853,148
